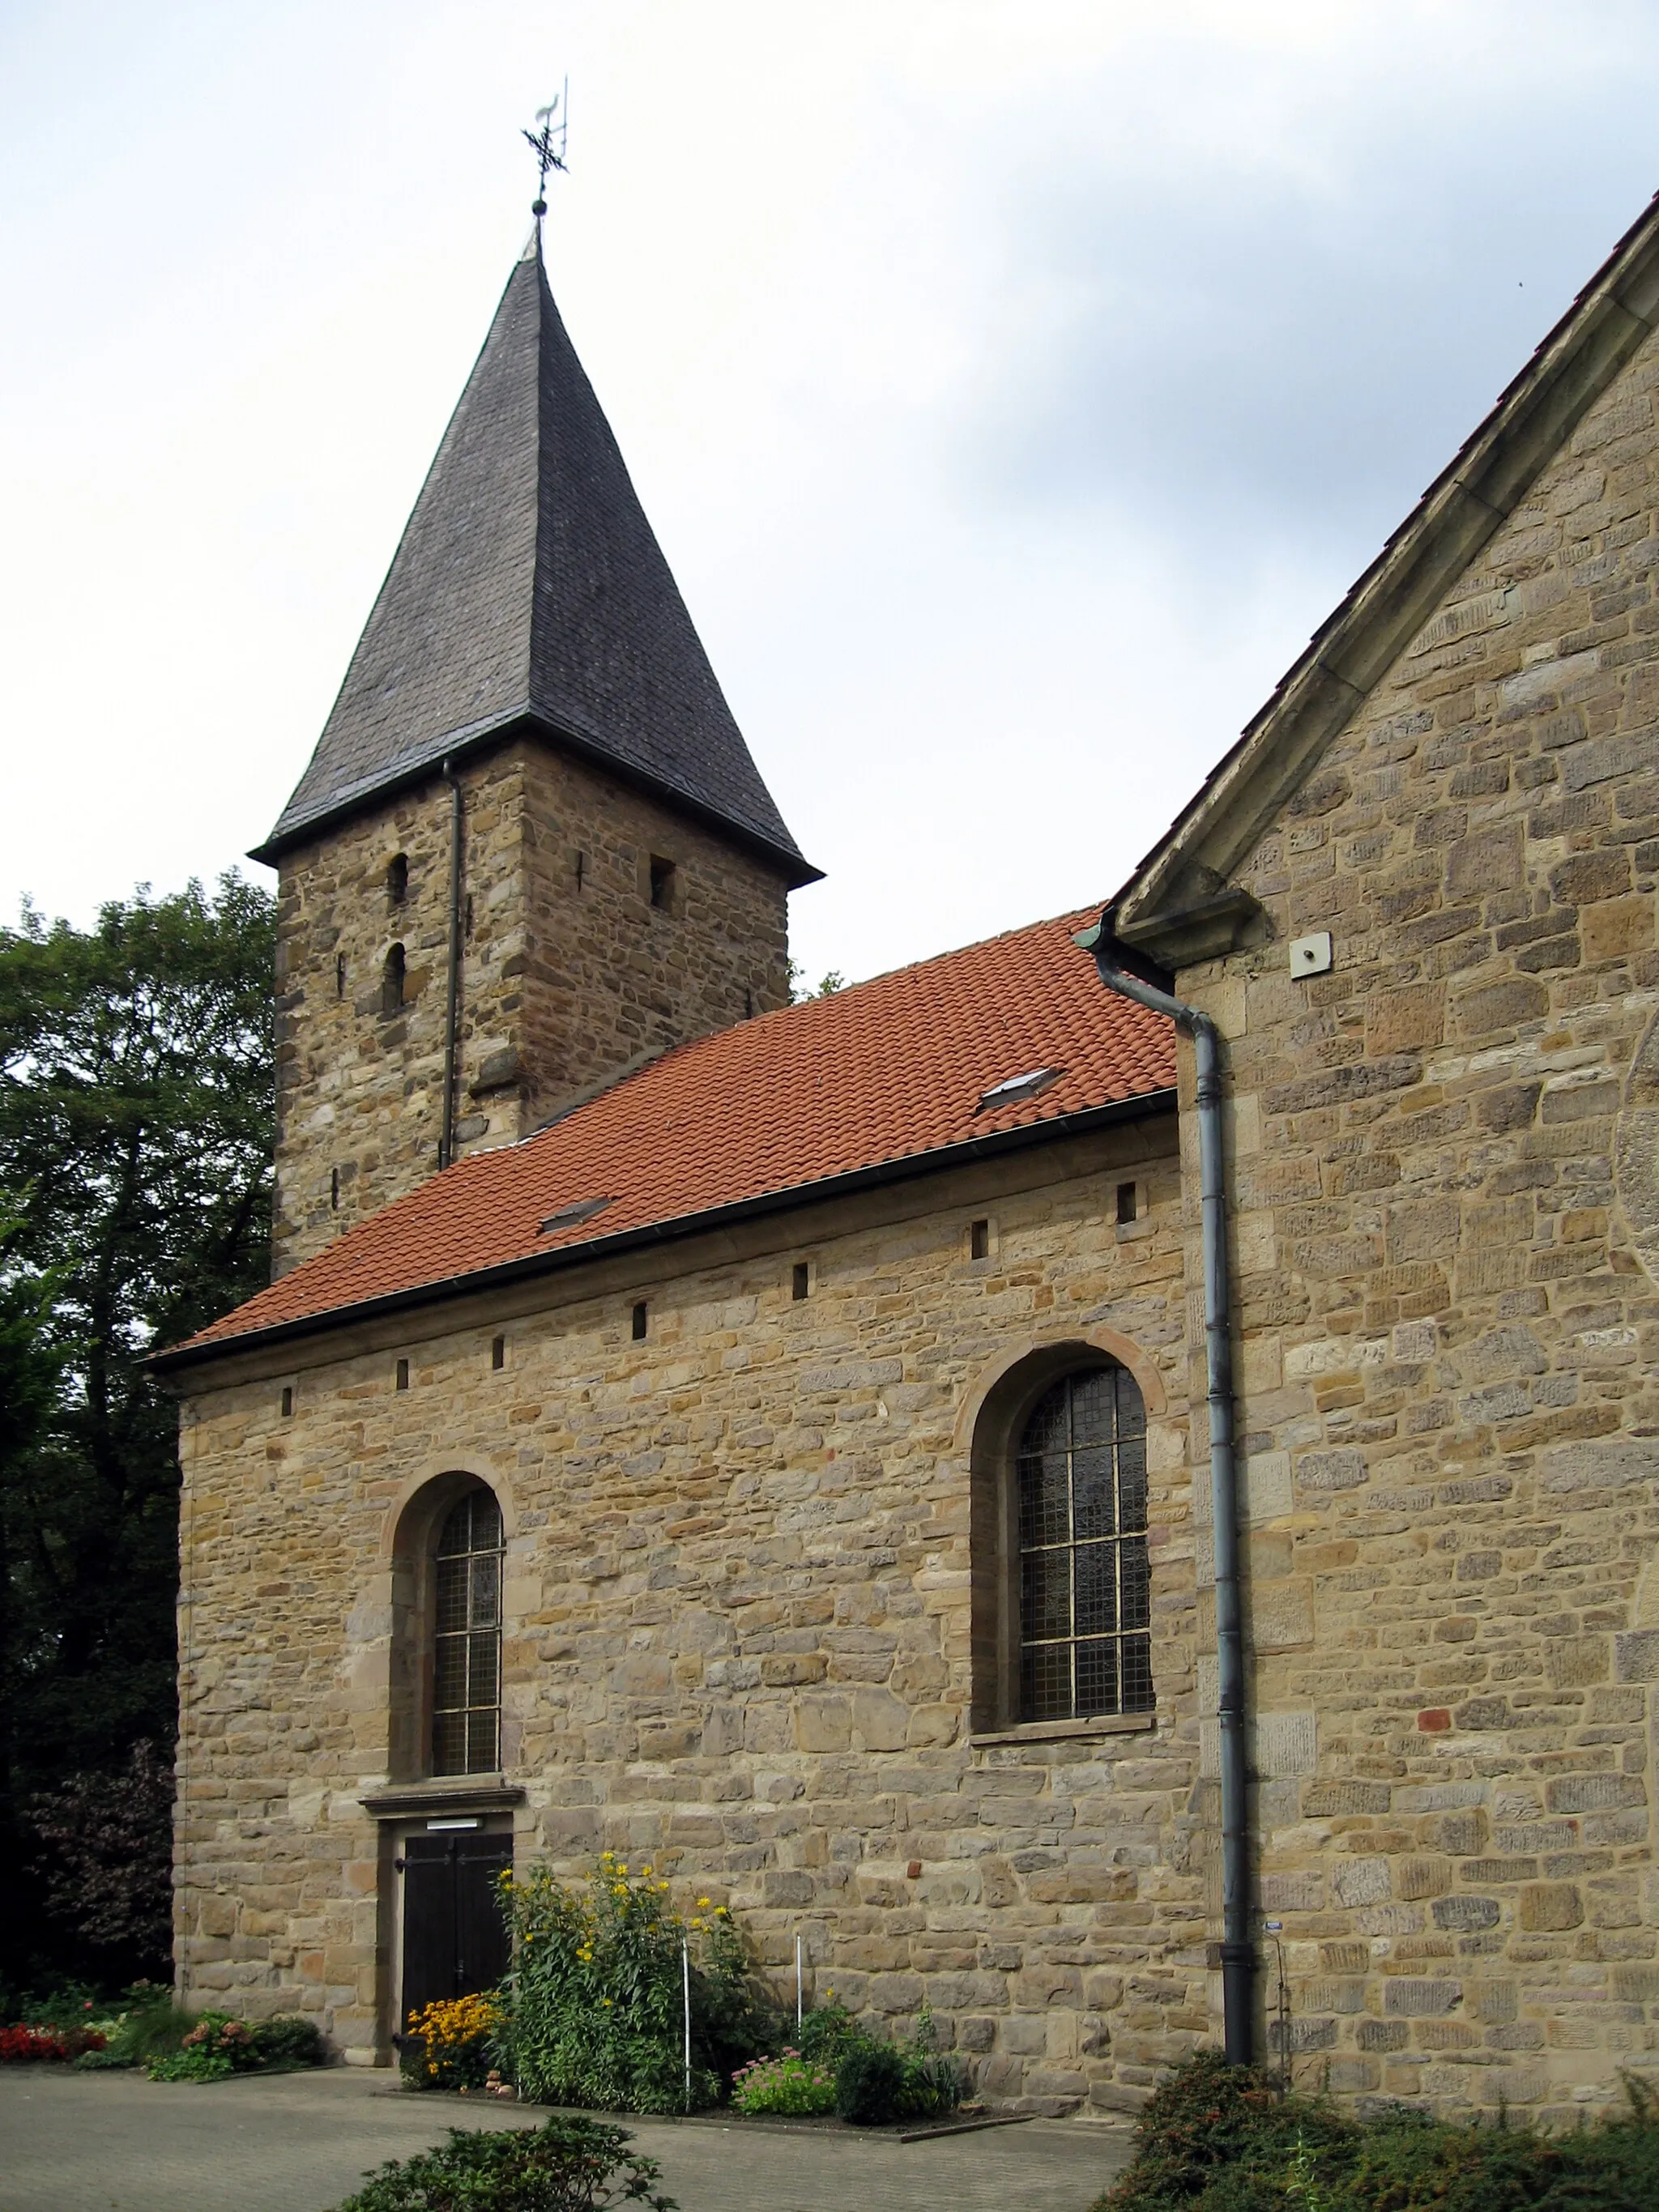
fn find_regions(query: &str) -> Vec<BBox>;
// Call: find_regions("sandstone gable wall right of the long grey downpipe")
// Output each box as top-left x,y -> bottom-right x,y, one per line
1179,307 -> 1659,2117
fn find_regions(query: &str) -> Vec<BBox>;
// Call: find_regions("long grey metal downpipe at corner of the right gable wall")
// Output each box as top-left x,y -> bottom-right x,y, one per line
1077,927 -> 1256,2066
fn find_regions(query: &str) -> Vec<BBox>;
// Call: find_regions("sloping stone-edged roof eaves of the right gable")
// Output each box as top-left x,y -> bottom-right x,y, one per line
1106,194 -> 1659,956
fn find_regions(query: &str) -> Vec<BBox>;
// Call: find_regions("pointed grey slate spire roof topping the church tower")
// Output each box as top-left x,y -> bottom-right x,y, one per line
254,244 -> 818,884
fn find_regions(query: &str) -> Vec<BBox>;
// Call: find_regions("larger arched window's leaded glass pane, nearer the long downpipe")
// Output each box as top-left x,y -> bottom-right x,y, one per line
1009,1365 -> 1154,1721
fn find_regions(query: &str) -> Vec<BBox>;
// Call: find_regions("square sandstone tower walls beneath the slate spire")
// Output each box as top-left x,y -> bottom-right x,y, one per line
272,741 -> 787,1274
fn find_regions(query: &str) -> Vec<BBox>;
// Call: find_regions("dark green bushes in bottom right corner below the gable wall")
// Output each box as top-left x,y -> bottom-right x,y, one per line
1095,2051 -> 1659,2212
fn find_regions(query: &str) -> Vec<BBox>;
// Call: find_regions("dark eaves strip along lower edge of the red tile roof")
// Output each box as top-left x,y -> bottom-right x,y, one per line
146,1086 -> 1175,1376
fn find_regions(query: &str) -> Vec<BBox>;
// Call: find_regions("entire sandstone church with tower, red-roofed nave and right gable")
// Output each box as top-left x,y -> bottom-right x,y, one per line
157,203 -> 1659,2117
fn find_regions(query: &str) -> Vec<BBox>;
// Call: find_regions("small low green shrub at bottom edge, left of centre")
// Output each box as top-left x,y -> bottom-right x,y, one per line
336,2115 -> 675,2212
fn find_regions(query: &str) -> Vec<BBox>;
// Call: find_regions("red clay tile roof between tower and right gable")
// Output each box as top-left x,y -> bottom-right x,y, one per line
161,907 -> 1175,1362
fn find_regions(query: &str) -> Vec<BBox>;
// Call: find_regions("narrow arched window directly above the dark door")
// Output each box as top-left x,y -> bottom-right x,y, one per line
431,1486 -> 502,1774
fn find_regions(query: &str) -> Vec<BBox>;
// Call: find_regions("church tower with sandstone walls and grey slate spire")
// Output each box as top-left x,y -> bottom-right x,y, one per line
252,245 -> 818,1274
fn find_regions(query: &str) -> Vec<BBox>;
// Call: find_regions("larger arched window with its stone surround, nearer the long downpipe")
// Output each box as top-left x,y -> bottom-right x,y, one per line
965,1329 -> 1166,1732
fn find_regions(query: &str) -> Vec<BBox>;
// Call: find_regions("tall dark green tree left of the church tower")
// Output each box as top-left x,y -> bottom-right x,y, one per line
0,874 -> 275,1967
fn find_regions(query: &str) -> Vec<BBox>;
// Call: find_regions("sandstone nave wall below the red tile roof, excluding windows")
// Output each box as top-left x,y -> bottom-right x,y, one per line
177,1115 -> 1217,2110
